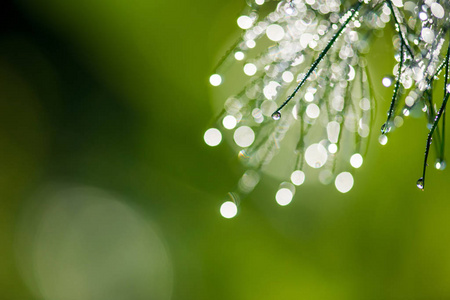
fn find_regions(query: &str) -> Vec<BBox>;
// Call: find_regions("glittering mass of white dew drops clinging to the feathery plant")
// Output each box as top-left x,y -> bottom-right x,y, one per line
204,0 -> 445,218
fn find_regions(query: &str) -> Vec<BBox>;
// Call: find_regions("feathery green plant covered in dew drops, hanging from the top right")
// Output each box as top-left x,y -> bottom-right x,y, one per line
204,0 -> 450,217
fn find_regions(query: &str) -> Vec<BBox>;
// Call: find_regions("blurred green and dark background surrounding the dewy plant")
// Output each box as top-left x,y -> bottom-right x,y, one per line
0,0 -> 450,300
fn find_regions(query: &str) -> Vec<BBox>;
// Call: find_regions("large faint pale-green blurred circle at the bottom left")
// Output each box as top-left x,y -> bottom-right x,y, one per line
17,185 -> 173,300
